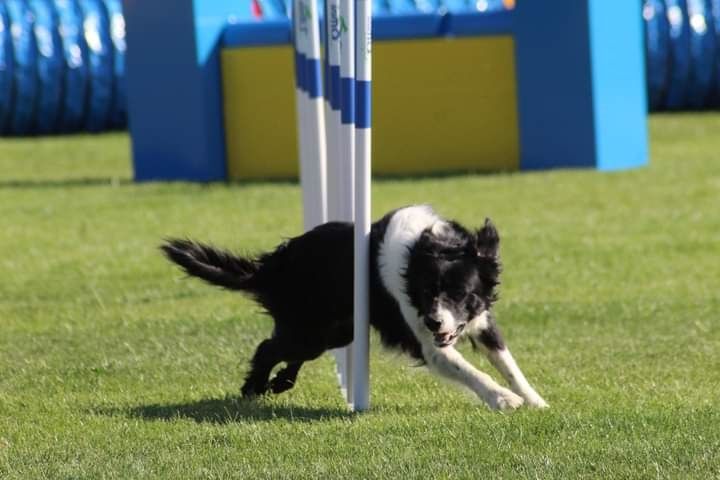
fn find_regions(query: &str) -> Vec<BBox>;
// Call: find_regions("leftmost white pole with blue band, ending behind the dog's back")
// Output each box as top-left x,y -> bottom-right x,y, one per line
292,0 -> 327,230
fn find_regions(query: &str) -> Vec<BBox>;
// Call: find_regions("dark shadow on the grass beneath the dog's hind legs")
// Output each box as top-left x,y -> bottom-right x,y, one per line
111,397 -> 352,424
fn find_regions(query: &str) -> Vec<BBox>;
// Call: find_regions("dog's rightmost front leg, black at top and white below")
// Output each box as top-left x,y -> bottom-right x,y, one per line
468,312 -> 548,408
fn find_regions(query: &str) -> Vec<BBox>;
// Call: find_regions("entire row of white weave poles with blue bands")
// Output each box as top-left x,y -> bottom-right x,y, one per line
292,0 -> 372,411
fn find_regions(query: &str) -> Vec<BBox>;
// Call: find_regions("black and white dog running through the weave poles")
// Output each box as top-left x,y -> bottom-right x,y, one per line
162,205 -> 547,410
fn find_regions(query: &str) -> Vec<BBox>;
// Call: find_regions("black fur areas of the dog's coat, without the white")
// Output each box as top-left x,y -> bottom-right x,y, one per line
161,207 -> 502,395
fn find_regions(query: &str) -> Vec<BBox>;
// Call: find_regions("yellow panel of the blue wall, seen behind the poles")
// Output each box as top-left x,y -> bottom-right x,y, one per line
222,36 -> 519,179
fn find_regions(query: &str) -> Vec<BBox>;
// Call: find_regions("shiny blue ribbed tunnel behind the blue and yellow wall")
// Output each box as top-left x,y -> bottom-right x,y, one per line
0,0 -> 720,135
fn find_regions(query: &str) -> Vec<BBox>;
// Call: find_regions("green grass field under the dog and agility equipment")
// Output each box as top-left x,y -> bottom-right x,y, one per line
0,114 -> 720,479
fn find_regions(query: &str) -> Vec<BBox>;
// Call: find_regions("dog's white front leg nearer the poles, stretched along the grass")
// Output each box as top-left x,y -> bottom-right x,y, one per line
423,344 -> 523,410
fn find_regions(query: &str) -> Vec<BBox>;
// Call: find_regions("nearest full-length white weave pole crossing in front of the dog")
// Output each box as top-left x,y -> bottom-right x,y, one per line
352,0 -> 372,411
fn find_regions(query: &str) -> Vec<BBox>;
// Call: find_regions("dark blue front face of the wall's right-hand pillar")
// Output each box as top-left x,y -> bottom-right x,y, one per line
515,0 -> 596,170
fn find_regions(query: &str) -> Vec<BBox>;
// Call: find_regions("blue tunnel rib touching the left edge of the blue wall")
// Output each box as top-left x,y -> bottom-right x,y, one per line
105,0 -> 127,128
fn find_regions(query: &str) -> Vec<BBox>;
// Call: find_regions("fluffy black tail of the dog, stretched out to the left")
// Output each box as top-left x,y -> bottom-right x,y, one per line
160,239 -> 260,291
